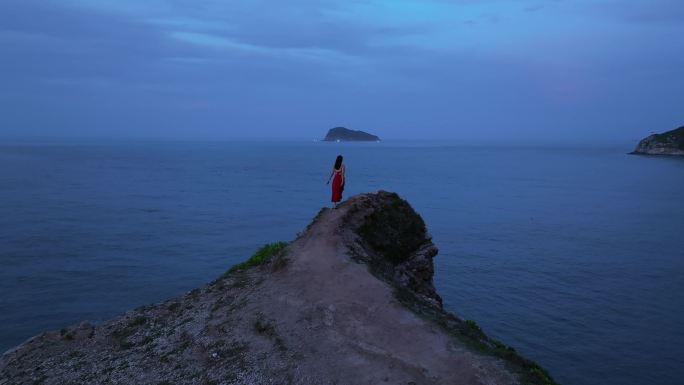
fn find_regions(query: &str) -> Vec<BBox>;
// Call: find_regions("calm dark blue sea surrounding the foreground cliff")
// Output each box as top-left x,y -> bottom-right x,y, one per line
0,142 -> 684,385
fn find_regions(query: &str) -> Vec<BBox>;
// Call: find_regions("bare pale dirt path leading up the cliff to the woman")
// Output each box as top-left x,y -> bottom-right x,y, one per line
236,201 -> 515,384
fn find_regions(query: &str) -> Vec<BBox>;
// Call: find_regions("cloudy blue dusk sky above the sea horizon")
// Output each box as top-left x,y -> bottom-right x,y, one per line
0,0 -> 684,141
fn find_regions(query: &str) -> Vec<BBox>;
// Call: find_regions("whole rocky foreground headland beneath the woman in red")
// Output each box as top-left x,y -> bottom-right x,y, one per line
0,191 -> 553,385
